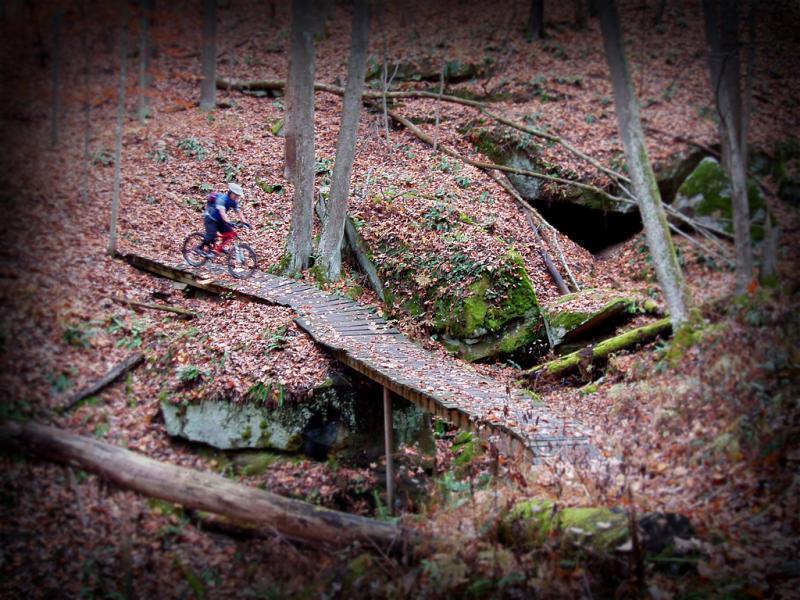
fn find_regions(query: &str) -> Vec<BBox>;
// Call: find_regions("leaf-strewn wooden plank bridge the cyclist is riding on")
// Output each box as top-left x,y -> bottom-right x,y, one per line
122,254 -> 599,461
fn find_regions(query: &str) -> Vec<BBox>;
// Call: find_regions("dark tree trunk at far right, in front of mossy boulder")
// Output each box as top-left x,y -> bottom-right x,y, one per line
703,0 -> 753,293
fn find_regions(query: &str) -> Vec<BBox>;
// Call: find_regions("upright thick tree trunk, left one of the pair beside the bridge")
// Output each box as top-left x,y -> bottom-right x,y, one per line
286,0 -> 314,274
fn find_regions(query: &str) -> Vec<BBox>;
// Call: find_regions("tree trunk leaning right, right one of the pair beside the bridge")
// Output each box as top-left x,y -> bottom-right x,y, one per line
318,0 -> 369,281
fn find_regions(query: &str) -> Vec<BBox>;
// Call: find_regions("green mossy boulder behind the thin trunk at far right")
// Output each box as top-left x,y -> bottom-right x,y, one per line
674,157 -> 767,240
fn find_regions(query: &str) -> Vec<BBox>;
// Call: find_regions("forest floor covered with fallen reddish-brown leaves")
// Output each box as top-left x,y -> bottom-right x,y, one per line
0,1 -> 800,598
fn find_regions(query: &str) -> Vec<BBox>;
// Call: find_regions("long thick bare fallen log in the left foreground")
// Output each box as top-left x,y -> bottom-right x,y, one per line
0,421 -> 423,550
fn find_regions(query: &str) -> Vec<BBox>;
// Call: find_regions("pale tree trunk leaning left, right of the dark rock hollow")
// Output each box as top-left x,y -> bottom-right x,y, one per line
598,0 -> 689,331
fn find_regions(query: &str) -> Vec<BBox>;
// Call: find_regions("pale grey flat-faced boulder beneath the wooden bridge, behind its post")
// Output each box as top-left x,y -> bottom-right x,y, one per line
161,384 -> 432,463
